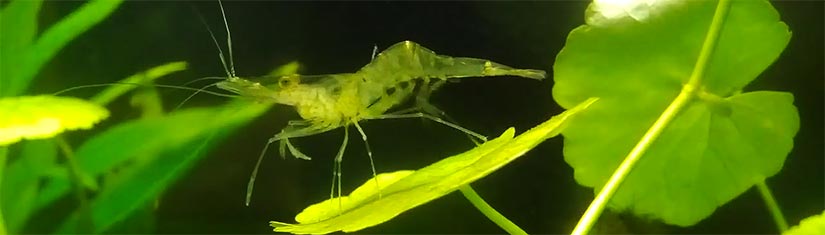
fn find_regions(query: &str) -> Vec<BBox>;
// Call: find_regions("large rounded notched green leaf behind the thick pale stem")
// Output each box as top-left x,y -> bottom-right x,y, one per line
553,1 -> 799,226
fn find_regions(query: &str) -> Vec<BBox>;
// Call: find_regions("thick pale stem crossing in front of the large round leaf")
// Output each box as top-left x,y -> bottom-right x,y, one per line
572,0 -> 730,235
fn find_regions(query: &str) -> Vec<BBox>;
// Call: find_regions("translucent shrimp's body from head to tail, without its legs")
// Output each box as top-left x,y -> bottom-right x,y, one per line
218,41 -> 545,127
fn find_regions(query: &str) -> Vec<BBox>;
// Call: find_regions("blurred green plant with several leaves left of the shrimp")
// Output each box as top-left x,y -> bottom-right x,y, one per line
0,0 -> 268,234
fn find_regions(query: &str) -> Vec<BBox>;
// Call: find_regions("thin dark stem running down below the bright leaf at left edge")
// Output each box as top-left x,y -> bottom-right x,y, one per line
54,136 -> 94,233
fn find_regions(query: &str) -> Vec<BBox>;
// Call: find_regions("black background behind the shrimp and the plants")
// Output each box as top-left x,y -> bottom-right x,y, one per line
30,1 -> 825,234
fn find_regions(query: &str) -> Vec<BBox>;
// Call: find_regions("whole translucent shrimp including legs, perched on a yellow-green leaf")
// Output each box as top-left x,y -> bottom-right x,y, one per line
217,41 -> 546,204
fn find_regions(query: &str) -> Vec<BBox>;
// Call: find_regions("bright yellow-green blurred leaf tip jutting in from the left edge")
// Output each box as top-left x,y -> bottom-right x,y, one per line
0,95 -> 109,146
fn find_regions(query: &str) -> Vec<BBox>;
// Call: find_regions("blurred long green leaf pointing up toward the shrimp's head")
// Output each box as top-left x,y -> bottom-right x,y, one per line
36,103 -> 269,218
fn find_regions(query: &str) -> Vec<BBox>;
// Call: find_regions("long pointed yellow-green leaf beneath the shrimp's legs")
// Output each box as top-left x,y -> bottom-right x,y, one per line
270,98 -> 596,234
